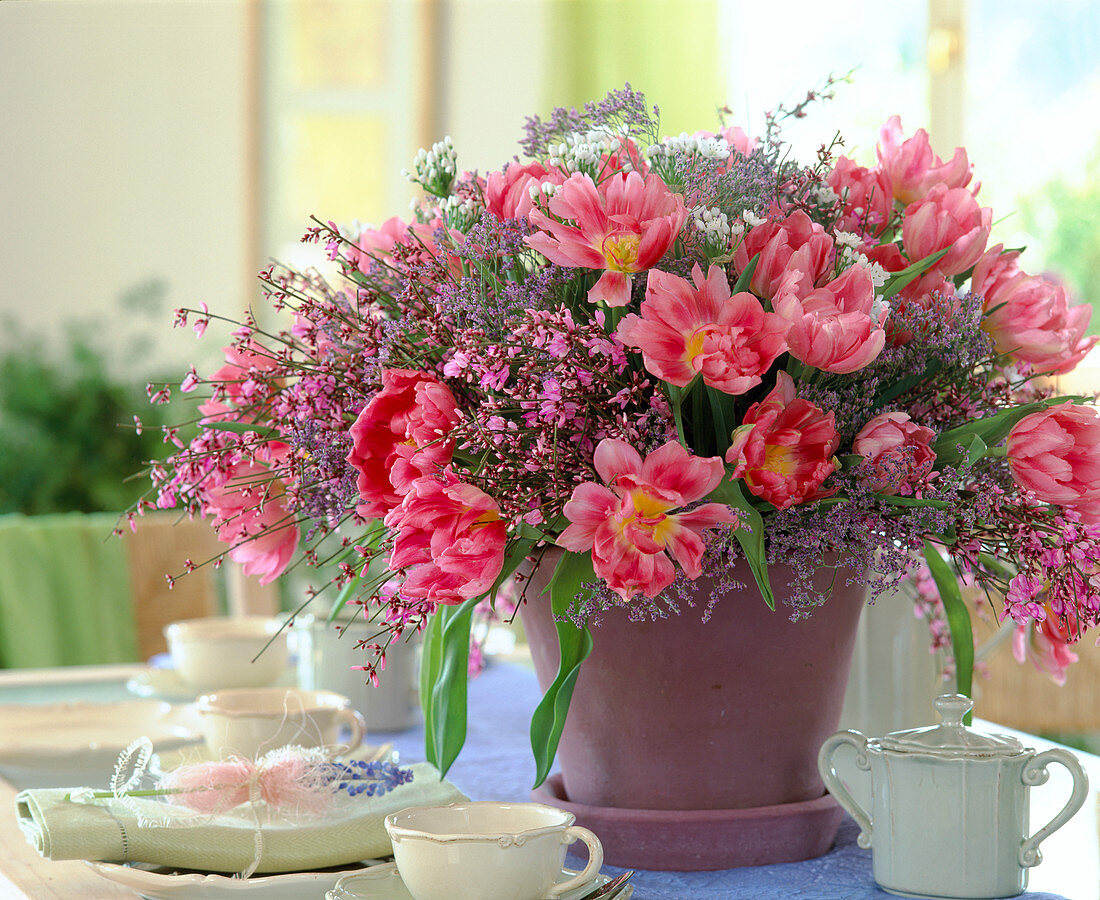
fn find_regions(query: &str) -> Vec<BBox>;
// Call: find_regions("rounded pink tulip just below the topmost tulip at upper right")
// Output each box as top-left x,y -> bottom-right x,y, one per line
901,185 -> 993,275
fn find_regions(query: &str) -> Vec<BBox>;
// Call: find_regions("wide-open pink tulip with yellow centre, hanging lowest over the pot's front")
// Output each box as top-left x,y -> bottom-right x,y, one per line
558,438 -> 737,600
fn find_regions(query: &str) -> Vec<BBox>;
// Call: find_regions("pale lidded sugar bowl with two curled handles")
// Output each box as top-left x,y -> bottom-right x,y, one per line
817,694 -> 1089,900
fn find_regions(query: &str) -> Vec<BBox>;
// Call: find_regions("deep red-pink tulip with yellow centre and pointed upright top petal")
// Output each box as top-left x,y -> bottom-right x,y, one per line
726,372 -> 839,509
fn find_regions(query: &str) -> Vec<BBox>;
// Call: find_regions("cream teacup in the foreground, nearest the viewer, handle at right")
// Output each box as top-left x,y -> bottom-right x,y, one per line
386,801 -> 604,900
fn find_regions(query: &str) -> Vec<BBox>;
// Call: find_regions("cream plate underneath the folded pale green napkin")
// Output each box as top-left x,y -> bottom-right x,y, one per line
88,860 -> 387,900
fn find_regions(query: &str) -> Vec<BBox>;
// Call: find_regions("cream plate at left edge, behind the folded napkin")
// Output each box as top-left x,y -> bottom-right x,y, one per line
0,700 -> 201,789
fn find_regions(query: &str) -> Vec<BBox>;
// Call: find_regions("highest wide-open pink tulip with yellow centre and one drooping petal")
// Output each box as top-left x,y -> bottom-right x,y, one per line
524,172 -> 688,306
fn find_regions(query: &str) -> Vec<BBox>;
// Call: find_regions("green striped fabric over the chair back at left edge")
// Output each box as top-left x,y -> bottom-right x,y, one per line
0,513 -> 138,669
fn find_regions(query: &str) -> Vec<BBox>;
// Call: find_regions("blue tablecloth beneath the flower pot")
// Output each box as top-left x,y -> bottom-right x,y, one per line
382,663 -> 1065,900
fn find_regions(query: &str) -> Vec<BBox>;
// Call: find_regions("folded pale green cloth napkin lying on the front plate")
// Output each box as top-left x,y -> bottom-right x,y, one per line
15,762 -> 466,872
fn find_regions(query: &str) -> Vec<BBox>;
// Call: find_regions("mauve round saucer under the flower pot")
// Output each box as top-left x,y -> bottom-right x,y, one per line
531,772 -> 844,871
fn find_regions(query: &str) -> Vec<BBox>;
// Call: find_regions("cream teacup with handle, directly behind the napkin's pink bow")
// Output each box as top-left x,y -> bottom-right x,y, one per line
195,688 -> 366,759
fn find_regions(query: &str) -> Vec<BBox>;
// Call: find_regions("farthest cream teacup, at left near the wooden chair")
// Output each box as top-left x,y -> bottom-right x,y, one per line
164,616 -> 288,691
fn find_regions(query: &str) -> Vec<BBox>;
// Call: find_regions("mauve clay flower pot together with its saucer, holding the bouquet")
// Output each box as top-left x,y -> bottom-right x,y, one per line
521,551 -> 866,869
